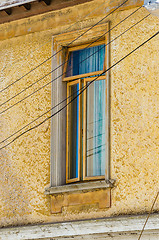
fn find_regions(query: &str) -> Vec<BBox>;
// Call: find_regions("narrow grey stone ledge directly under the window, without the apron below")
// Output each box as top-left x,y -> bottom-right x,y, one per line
45,179 -> 115,195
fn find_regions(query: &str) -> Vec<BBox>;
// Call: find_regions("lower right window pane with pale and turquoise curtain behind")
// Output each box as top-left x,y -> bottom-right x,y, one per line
86,80 -> 105,177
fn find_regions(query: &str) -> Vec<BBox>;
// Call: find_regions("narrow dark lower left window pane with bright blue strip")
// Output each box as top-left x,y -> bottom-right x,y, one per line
68,84 -> 79,179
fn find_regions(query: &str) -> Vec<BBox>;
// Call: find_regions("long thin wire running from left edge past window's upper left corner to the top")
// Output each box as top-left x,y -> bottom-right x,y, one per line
0,0 -> 128,93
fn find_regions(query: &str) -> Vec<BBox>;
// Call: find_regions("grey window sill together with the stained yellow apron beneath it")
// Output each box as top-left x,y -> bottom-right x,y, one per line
45,180 -> 114,214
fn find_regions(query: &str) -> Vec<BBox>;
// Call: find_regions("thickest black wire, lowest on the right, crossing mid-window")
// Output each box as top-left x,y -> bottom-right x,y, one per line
0,31 -> 159,150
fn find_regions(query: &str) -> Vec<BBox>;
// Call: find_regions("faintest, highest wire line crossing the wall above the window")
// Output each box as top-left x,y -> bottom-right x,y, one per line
2,2 -> 105,72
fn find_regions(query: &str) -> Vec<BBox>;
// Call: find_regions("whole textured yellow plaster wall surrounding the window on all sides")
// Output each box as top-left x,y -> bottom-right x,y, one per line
0,1 -> 159,226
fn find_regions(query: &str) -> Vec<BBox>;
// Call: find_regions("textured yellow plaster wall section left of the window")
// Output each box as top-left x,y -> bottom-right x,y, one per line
0,29 -> 51,225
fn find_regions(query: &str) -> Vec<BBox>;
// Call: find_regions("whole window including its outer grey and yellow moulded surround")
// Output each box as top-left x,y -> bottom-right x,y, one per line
50,23 -> 110,187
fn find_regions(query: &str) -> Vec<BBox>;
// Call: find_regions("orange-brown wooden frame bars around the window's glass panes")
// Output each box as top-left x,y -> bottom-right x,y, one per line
63,37 -> 107,183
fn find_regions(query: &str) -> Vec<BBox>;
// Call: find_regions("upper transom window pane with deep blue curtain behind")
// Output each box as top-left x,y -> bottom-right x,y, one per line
67,44 -> 105,76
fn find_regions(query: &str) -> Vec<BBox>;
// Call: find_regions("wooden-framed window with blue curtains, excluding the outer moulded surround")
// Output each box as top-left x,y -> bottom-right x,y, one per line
64,41 -> 106,183
